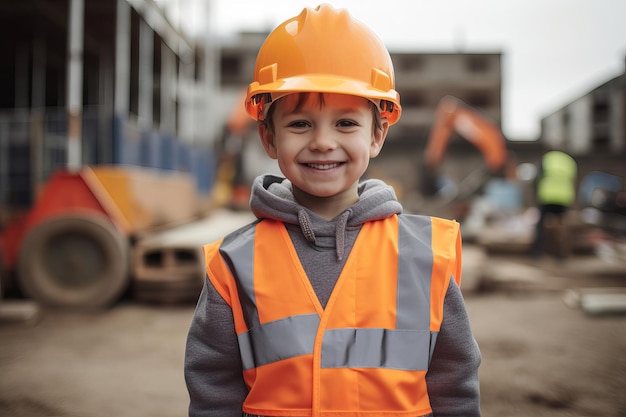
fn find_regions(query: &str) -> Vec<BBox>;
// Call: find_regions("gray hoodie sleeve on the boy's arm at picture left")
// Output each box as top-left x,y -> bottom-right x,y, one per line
184,279 -> 247,417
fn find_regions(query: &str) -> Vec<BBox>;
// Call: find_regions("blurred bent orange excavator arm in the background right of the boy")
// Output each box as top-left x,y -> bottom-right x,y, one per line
421,96 -> 507,196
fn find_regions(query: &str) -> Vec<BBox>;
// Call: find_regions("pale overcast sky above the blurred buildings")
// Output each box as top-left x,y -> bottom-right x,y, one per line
159,0 -> 626,139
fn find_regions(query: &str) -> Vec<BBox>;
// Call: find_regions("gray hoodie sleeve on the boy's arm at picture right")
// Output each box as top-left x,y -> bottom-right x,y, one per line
426,279 -> 481,417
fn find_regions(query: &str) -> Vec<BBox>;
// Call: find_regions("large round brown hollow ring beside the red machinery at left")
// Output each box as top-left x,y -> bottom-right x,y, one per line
17,213 -> 129,309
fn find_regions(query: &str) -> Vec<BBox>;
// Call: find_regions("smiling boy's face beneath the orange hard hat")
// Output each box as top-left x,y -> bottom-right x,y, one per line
259,94 -> 389,214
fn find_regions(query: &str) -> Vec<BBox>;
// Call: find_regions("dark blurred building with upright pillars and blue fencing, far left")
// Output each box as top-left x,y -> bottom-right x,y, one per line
0,0 -> 212,214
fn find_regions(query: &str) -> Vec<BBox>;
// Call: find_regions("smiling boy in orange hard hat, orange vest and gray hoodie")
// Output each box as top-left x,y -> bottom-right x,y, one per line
185,5 -> 480,417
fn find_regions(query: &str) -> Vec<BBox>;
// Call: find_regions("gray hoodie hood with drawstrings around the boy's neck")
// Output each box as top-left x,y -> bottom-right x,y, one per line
250,175 -> 402,260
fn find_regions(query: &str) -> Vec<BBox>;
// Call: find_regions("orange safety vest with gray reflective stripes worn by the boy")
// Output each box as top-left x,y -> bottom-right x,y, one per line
204,215 -> 461,417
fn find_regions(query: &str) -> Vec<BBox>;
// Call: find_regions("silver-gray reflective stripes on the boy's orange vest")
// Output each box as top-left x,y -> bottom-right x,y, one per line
220,216 -> 436,370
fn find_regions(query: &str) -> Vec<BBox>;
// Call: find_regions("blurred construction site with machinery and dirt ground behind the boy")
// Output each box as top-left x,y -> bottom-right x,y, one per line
0,0 -> 626,417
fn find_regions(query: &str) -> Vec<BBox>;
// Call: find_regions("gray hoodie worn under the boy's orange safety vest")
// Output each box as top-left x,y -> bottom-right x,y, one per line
185,175 -> 481,417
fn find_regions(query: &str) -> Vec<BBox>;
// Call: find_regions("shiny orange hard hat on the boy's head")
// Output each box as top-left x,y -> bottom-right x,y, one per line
245,4 -> 402,125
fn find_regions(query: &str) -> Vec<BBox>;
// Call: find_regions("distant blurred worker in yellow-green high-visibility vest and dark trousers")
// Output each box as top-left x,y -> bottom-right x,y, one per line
531,151 -> 578,258
